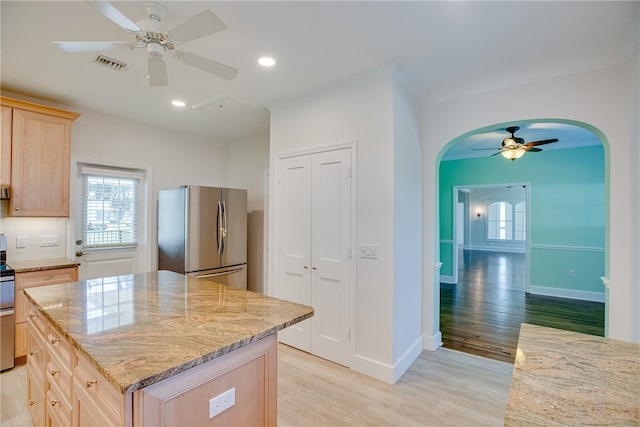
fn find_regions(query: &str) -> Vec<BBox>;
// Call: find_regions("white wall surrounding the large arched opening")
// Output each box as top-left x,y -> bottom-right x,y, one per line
422,61 -> 640,342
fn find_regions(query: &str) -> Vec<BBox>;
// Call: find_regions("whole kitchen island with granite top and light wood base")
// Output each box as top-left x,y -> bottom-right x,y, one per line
25,271 -> 313,425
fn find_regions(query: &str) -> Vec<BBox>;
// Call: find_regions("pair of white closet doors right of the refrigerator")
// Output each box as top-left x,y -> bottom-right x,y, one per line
276,149 -> 351,365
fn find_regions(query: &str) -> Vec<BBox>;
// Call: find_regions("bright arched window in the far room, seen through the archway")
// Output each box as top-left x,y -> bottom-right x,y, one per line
487,202 -> 527,241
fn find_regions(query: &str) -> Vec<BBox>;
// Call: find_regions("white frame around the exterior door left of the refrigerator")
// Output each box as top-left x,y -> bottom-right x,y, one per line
66,156 -> 157,280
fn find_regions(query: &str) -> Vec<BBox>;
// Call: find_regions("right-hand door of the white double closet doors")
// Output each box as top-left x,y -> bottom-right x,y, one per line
311,149 -> 351,366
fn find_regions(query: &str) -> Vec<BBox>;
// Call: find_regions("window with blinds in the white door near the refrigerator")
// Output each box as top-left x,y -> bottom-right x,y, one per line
80,166 -> 143,249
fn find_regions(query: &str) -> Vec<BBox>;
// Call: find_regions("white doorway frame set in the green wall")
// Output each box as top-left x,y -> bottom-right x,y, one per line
452,181 -> 531,293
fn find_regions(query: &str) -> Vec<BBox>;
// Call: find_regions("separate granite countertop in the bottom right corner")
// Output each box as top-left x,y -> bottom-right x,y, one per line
504,323 -> 640,426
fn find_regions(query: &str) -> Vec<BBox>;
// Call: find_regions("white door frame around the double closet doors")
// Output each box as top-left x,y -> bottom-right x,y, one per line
267,140 -> 358,366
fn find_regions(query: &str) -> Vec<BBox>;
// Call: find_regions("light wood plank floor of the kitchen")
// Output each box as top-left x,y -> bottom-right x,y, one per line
0,344 -> 513,427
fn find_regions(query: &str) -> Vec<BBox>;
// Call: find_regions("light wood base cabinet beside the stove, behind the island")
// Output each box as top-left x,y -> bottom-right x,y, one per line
14,267 -> 78,363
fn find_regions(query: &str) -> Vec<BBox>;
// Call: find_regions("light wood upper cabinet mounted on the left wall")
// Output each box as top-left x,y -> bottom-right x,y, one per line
0,97 -> 80,217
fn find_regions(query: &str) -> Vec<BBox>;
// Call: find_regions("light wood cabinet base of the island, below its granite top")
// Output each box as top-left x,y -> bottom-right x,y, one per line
27,306 -> 278,427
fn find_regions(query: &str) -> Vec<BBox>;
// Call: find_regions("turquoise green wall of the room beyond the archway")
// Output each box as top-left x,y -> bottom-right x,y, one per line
439,145 -> 605,293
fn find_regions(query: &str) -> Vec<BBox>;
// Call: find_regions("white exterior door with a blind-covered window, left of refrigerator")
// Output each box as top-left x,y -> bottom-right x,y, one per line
72,163 -> 148,280
